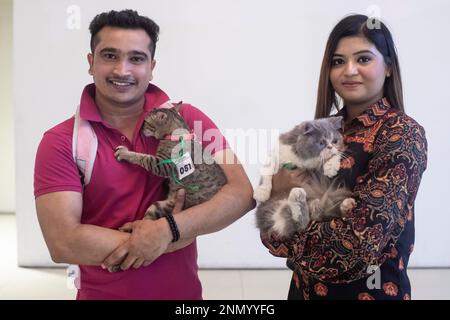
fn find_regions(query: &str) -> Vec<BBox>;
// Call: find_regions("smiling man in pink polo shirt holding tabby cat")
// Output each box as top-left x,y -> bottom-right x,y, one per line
34,10 -> 254,299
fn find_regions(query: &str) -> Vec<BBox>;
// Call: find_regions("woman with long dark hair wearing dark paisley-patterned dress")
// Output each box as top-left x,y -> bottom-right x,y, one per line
261,15 -> 427,300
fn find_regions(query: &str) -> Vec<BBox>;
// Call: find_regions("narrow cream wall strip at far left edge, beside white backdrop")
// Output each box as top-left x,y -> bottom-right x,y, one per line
0,0 -> 16,213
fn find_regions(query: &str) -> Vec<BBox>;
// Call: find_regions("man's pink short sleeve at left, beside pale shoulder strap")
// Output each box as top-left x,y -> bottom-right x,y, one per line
34,118 -> 83,198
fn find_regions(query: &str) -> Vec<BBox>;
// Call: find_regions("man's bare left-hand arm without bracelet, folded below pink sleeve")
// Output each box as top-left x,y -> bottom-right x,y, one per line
36,191 -> 130,265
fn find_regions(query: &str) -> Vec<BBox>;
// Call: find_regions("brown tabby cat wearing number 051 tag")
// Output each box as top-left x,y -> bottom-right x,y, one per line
115,103 -> 227,220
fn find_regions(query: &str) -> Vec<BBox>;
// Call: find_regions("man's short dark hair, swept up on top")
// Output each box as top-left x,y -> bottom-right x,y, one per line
89,9 -> 159,58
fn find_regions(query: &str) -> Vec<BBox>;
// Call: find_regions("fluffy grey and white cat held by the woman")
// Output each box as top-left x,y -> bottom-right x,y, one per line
254,117 -> 355,237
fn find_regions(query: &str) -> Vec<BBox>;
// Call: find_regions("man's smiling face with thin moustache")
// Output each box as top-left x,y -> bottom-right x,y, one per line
88,27 -> 155,107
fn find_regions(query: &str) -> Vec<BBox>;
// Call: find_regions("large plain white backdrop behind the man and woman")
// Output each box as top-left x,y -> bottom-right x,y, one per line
14,0 -> 450,268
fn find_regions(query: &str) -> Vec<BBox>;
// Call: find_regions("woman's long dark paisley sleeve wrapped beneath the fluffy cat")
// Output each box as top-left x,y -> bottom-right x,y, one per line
263,116 -> 427,283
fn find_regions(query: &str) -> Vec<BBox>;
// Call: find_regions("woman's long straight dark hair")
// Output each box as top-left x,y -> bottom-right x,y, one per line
315,14 -> 404,119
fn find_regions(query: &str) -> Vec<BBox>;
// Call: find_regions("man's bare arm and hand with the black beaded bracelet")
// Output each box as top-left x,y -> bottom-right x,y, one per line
104,149 -> 255,270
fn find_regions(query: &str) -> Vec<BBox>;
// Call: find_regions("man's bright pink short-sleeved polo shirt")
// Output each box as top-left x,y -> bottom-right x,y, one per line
34,84 -> 227,299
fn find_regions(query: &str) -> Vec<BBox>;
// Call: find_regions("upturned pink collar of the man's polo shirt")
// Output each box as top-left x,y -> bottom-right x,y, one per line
80,83 -> 169,122
